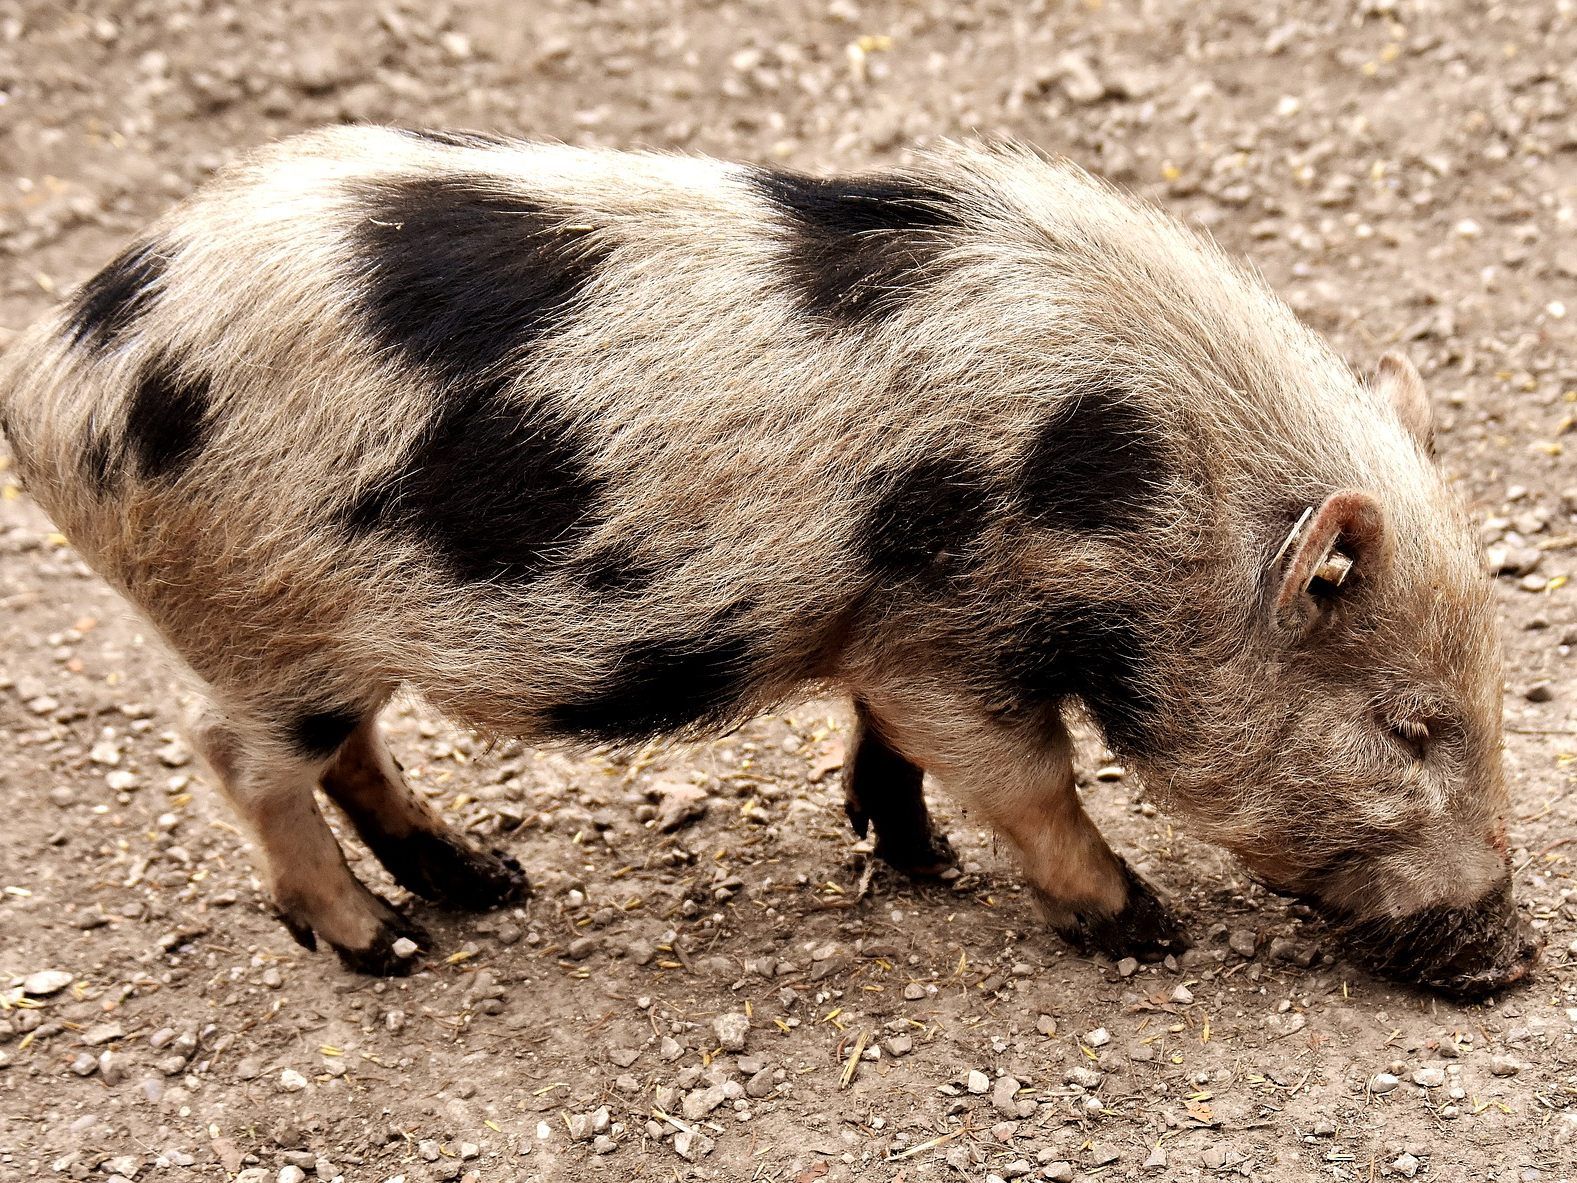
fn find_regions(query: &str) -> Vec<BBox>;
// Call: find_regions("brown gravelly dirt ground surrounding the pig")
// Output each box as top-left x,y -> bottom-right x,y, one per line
0,0 -> 1577,1183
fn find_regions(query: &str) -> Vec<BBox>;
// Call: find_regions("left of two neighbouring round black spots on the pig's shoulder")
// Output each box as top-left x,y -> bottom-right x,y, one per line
856,456 -> 994,577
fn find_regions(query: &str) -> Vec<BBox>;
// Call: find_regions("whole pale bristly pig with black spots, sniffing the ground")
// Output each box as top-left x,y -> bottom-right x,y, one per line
0,128 -> 1534,994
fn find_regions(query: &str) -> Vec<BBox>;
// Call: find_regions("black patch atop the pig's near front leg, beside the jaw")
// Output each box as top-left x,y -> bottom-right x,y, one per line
984,603 -> 1159,754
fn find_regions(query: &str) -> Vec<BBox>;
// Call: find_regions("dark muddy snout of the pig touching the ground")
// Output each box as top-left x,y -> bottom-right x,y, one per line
1340,882 -> 1544,998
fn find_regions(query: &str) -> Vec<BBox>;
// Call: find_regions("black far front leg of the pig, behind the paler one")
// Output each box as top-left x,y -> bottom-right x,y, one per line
844,702 -> 957,875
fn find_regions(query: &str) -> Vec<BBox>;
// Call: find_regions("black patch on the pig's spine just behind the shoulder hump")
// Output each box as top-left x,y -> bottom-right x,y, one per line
752,170 -> 959,323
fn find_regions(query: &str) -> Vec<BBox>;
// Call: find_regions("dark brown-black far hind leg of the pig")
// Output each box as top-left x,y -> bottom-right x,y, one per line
323,715 -> 530,912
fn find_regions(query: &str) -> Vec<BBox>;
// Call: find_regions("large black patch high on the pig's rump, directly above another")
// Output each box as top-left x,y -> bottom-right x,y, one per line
353,177 -> 607,386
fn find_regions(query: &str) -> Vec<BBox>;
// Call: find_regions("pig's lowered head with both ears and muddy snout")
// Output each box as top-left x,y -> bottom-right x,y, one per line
1156,355 -> 1538,995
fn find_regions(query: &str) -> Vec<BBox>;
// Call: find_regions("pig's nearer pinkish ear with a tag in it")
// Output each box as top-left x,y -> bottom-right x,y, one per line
1271,489 -> 1391,636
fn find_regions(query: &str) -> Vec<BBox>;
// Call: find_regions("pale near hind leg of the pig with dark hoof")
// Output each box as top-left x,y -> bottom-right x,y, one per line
191,708 -> 427,975
